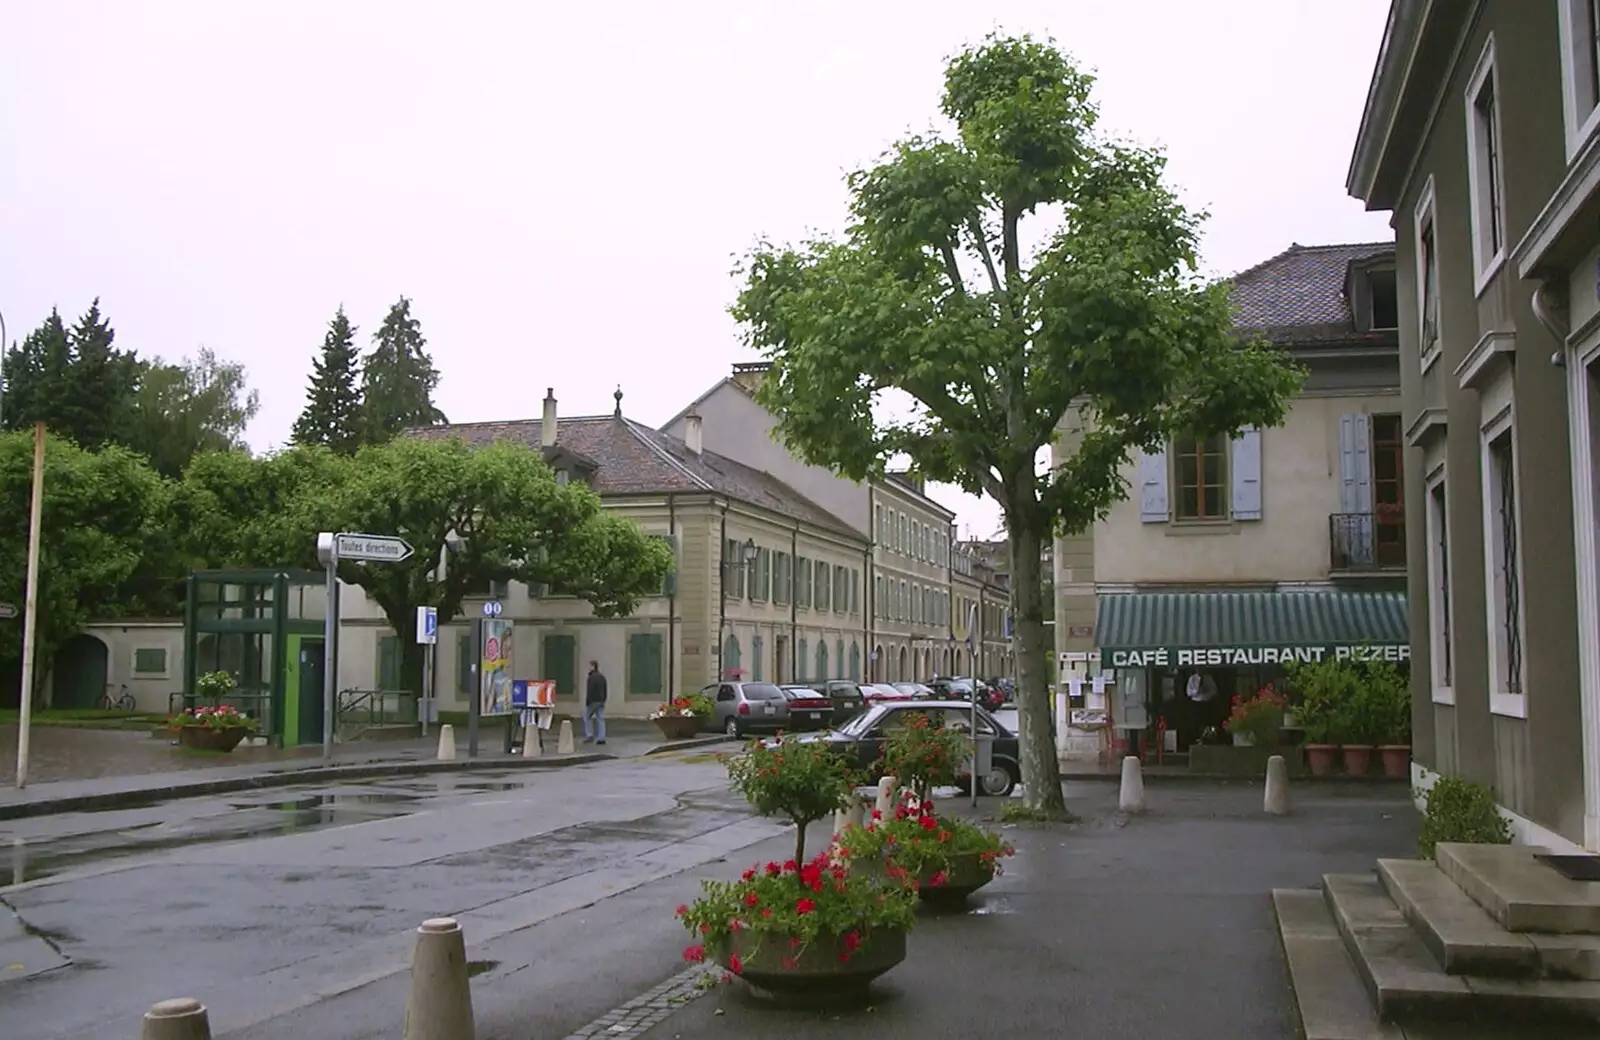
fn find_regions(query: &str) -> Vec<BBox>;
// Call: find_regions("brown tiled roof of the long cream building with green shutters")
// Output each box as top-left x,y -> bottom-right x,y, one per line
408,416 -> 856,536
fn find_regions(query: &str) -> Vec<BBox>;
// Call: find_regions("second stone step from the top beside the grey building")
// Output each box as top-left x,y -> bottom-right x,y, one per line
1378,859 -> 1600,979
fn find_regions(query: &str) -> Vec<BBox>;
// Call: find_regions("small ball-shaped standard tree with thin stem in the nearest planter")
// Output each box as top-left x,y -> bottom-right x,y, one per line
728,741 -> 856,862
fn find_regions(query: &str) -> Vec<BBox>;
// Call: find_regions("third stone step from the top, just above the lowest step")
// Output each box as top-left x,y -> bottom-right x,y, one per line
1322,874 -> 1600,1030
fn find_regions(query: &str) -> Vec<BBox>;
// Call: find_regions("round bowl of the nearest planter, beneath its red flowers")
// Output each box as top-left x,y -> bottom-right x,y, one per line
707,928 -> 906,997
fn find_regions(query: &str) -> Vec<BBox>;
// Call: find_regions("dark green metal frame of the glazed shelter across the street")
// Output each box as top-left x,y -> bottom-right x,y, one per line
184,568 -> 333,744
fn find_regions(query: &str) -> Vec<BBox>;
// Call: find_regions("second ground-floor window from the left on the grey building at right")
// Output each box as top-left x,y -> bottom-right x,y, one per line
1483,419 -> 1525,717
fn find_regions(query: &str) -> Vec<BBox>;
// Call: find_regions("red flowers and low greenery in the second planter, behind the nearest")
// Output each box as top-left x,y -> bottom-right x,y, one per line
837,797 -> 1016,888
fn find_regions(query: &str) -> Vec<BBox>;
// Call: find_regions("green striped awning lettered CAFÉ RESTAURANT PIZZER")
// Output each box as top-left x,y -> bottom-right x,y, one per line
1094,590 -> 1411,667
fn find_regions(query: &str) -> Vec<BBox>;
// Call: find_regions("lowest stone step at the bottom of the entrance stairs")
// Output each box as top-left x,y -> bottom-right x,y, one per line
1272,888 -> 1405,1040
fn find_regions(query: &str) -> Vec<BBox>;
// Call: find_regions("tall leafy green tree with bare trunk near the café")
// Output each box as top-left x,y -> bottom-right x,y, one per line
733,37 -> 1298,811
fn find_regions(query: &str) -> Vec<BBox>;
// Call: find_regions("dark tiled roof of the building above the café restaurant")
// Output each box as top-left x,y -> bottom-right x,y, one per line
1230,242 -> 1395,341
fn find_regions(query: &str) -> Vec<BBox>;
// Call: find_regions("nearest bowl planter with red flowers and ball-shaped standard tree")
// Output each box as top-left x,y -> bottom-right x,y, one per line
678,729 -> 917,992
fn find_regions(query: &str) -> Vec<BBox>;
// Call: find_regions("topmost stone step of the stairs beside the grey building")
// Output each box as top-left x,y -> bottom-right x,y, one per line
1435,843 -> 1600,934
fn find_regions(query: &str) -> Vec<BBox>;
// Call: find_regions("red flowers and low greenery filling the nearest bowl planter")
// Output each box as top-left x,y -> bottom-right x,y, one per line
678,850 -> 917,974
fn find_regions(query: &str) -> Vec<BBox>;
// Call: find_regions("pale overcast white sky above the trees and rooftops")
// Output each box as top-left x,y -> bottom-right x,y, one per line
0,0 -> 1392,538
